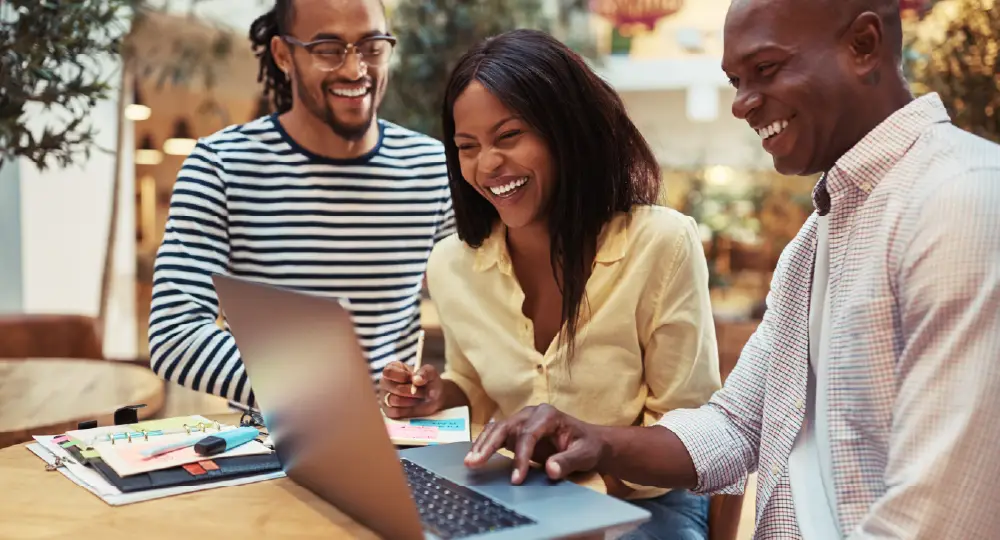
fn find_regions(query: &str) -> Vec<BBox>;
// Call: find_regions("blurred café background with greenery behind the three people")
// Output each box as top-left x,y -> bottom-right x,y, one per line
0,0 -> 1000,413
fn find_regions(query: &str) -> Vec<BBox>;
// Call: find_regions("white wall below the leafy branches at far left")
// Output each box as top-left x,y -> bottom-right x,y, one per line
19,63 -> 135,357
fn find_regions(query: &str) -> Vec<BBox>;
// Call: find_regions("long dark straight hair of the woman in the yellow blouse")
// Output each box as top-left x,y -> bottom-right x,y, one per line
442,30 -> 661,358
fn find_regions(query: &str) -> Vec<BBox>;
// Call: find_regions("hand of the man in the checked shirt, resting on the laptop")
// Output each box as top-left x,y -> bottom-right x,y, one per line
465,404 -> 608,484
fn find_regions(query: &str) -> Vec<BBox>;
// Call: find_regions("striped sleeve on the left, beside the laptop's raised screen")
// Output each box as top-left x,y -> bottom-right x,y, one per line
149,141 -> 254,405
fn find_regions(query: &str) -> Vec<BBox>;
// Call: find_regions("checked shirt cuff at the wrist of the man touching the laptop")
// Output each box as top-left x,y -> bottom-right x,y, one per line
656,406 -> 746,495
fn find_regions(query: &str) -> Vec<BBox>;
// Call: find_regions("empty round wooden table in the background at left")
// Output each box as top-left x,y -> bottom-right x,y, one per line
0,358 -> 164,448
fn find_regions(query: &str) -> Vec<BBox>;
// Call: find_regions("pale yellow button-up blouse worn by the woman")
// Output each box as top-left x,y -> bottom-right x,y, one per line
427,206 -> 721,498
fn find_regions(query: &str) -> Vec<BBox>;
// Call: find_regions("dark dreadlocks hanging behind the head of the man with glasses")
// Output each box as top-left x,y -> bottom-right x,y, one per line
250,0 -> 294,113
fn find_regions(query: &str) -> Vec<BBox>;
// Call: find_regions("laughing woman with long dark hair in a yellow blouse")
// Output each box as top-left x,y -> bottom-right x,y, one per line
380,30 -> 720,539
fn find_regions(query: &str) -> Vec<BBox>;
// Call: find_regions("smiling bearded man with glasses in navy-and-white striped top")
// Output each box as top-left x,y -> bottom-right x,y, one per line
149,0 -> 454,406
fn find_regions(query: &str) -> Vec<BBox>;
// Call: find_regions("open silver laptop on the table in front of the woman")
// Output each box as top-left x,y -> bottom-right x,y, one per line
213,275 -> 650,540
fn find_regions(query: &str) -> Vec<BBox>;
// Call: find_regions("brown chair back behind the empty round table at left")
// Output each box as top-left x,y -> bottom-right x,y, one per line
0,313 -> 104,359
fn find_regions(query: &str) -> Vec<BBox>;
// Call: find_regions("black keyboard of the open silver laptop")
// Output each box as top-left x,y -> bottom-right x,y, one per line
401,459 -> 535,538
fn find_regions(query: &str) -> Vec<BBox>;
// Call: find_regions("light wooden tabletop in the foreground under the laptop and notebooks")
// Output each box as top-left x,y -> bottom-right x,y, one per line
0,415 -> 603,540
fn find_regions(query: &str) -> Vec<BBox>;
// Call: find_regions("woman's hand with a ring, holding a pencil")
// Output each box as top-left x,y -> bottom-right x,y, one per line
379,362 -> 444,418
